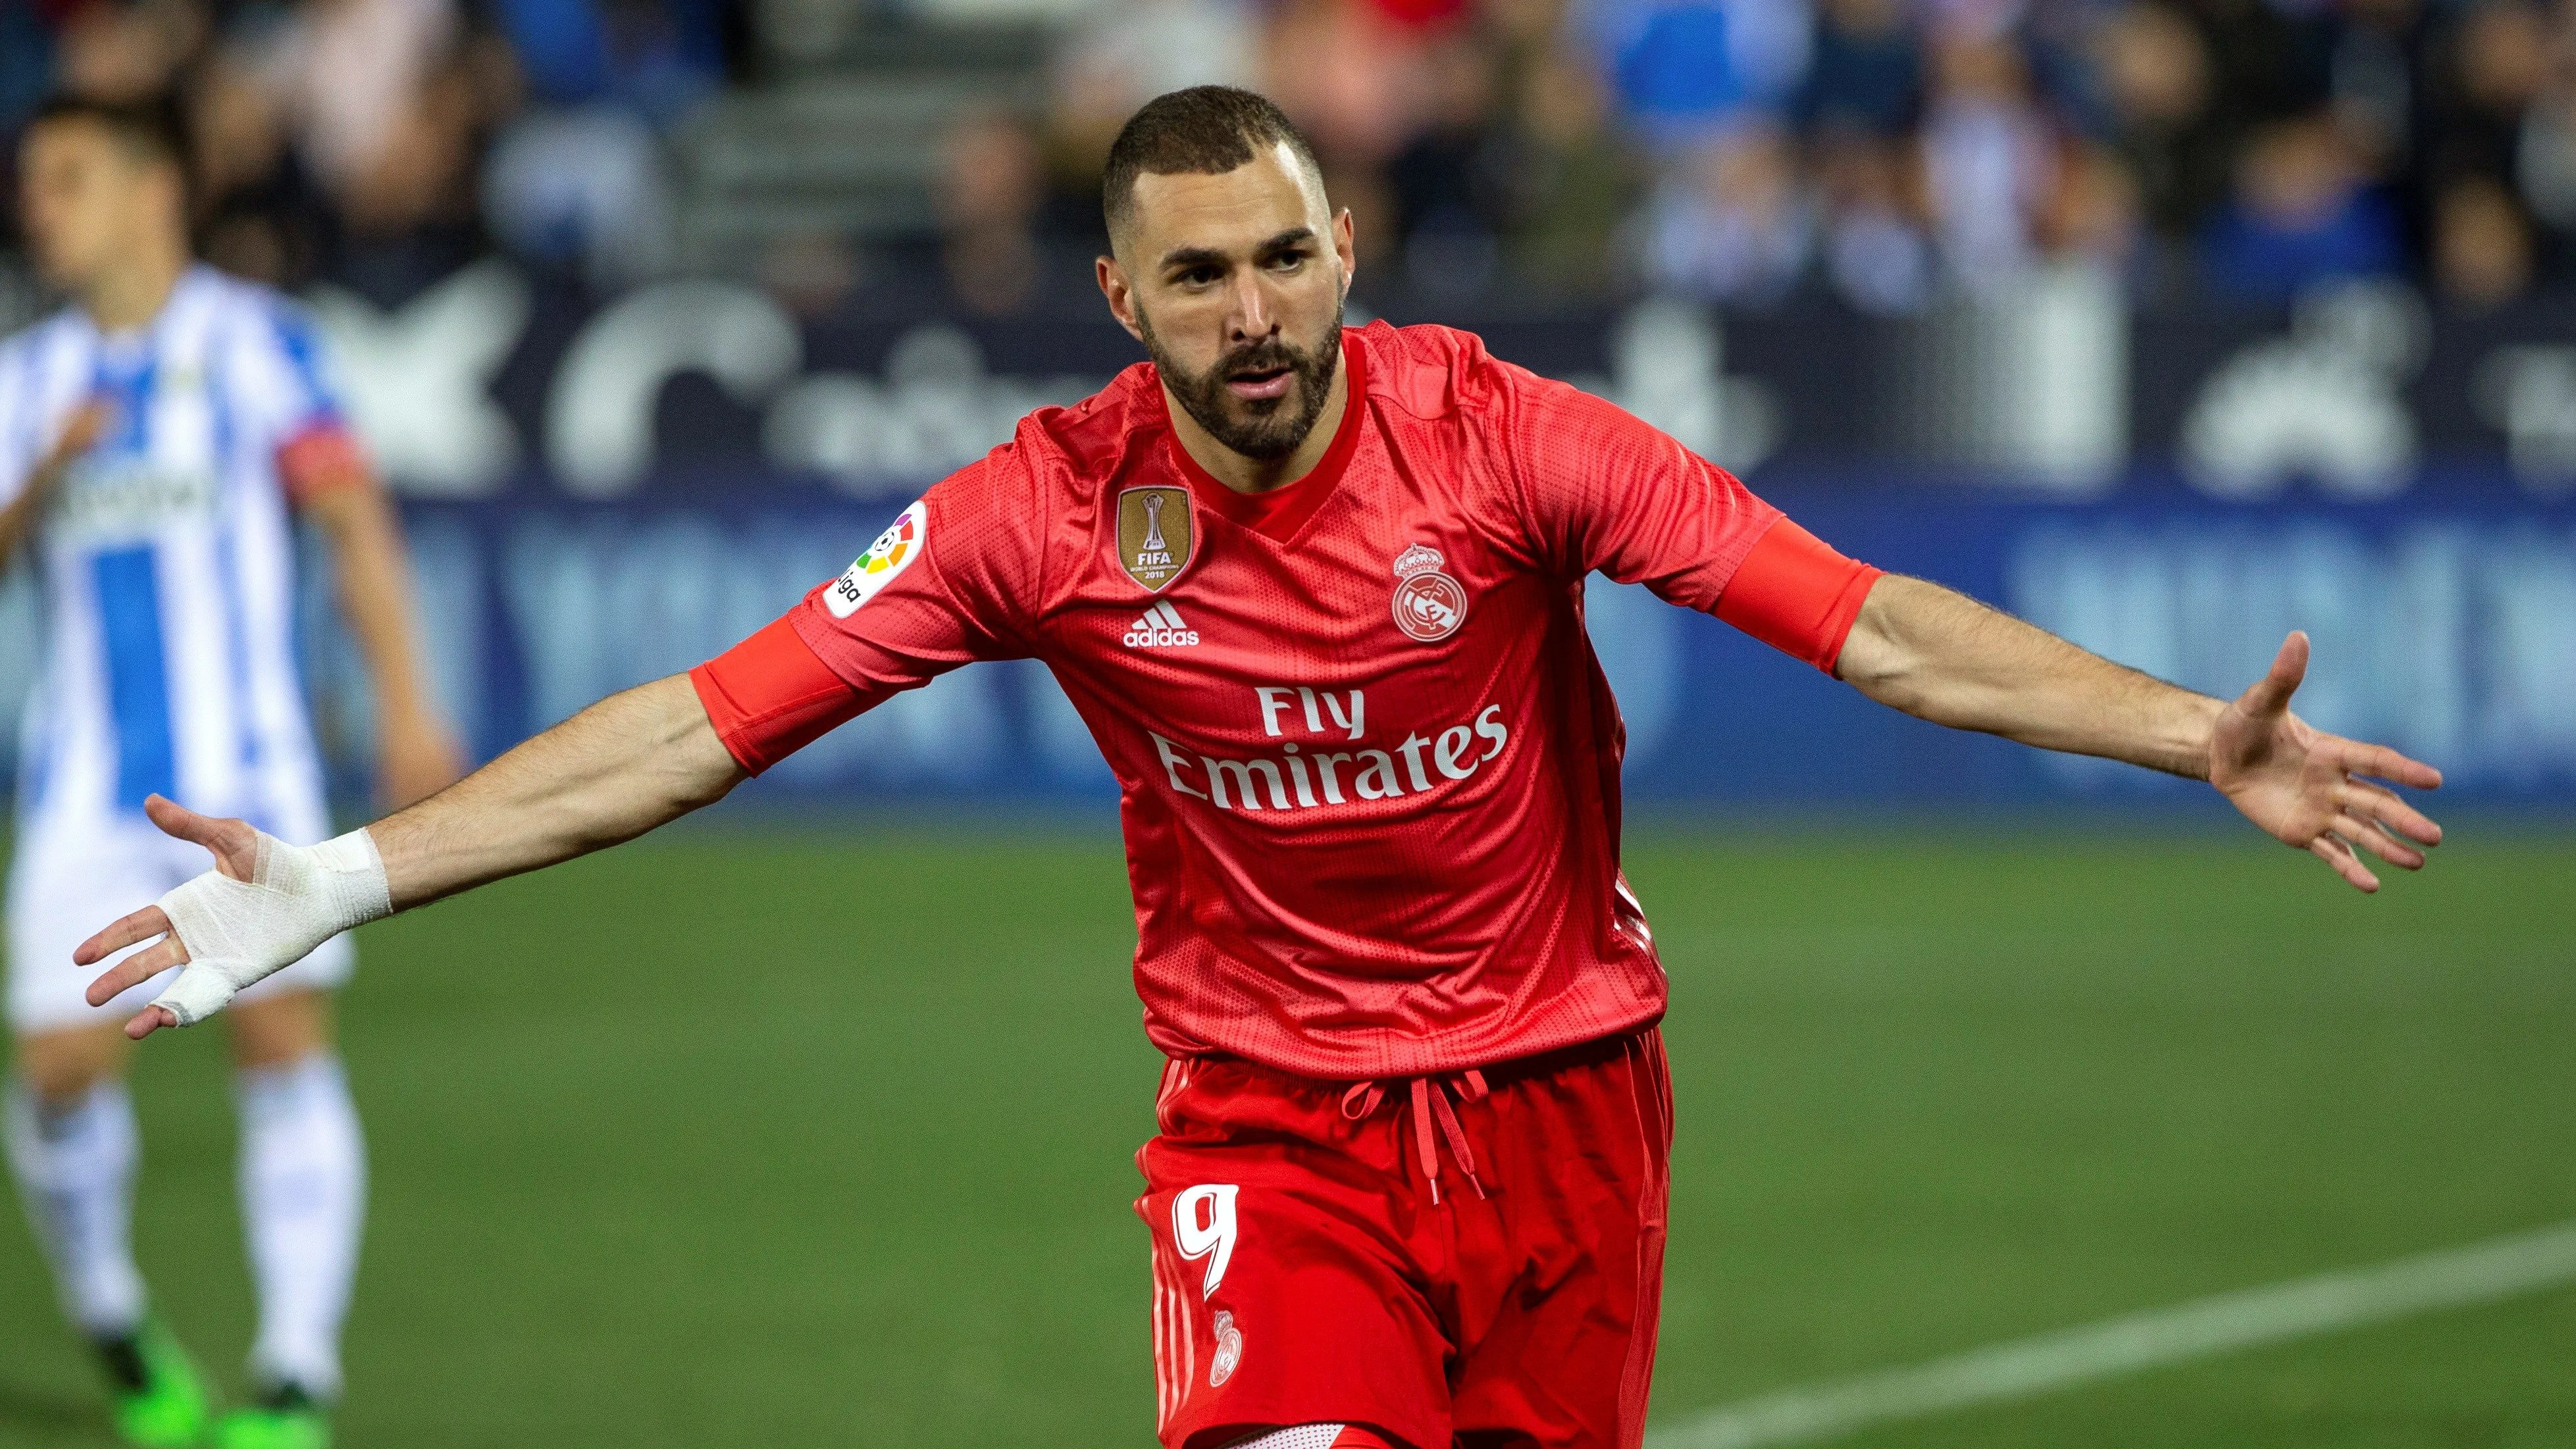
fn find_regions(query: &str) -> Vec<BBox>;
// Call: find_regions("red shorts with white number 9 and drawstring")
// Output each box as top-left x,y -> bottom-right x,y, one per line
1136,1029 -> 1672,1449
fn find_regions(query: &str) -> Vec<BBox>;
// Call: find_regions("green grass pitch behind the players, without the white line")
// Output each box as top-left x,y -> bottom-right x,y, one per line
0,819 -> 2576,1449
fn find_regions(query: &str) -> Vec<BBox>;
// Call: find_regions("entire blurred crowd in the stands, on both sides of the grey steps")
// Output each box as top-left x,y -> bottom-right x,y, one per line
0,0 -> 2576,314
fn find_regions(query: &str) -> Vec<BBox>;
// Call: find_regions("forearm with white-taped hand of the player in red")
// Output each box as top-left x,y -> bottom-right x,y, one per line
72,674 -> 747,1037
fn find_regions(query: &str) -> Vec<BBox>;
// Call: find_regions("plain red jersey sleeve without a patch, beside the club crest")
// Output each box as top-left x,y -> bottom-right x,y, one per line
1494,363 -> 1878,672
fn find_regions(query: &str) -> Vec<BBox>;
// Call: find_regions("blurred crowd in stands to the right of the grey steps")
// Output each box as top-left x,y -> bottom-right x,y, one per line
1048,0 -> 2576,311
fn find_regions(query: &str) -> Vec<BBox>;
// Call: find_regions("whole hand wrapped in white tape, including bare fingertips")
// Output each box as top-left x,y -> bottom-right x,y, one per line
72,796 -> 392,1040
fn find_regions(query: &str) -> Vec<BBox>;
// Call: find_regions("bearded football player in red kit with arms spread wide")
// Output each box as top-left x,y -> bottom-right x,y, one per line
82,88 -> 2440,1449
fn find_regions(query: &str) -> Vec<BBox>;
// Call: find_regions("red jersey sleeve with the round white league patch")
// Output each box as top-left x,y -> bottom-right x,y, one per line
688,448 -> 1043,775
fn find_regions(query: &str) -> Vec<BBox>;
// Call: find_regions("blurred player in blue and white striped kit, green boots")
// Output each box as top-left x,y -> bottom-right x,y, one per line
0,101 -> 459,1449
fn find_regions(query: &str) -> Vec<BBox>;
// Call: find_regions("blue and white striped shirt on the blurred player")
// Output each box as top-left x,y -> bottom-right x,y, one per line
0,268 -> 340,834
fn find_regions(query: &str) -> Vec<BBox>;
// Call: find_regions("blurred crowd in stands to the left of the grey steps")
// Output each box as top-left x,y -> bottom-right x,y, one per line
0,0 -> 747,304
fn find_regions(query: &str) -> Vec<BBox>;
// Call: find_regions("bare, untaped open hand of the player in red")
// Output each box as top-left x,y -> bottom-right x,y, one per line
2210,633 -> 2442,890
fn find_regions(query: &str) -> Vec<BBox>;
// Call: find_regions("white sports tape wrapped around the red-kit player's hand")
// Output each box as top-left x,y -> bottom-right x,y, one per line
152,831 -> 394,1027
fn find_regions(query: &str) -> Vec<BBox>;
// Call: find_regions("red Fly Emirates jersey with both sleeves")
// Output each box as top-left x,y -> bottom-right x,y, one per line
693,322 -> 1875,1081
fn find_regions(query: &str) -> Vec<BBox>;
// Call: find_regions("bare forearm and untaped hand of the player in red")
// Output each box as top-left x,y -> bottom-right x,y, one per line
1834,574 -> 2442,890
